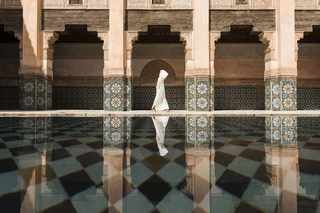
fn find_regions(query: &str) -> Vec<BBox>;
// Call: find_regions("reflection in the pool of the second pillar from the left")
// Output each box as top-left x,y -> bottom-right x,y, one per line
102,116 -> 131,212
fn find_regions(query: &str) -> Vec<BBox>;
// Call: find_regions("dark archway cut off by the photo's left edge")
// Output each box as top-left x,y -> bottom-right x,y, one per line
0,26 -> 20,110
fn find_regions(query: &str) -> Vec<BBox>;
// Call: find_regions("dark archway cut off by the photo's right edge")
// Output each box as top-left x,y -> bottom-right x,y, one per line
297,26 -> 320,110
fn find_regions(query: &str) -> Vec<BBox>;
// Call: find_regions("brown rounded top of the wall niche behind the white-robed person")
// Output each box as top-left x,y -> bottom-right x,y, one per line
135,59 -> 176,86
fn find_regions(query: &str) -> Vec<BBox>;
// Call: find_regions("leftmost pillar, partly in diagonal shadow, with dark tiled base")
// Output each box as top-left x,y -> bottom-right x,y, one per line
19,0 -> 51,110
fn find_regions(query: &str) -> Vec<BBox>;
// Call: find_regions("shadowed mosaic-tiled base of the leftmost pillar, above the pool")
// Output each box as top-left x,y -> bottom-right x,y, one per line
20,77 -> 52,110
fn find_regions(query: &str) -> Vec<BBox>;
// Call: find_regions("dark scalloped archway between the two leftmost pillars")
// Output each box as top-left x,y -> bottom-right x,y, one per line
52,25 -> 104,110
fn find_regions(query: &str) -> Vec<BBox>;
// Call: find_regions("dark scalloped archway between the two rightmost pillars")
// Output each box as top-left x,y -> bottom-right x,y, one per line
215,26 -> 266,110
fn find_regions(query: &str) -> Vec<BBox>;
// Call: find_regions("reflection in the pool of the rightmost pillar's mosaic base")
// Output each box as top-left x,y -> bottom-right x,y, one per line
265,116 -> 298,146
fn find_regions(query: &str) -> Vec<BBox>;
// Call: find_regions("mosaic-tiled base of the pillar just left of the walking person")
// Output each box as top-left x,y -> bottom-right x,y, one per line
103,77 -> 131,111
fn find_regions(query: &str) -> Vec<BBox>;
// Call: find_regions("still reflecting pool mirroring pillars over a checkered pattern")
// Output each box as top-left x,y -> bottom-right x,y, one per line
0,116 -> 320,213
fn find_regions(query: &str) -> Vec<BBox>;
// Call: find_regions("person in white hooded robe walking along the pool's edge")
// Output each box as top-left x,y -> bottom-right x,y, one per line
152,70 -> 169,111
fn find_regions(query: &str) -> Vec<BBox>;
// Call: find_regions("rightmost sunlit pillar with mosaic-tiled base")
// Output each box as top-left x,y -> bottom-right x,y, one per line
265,0 -> 297,111
